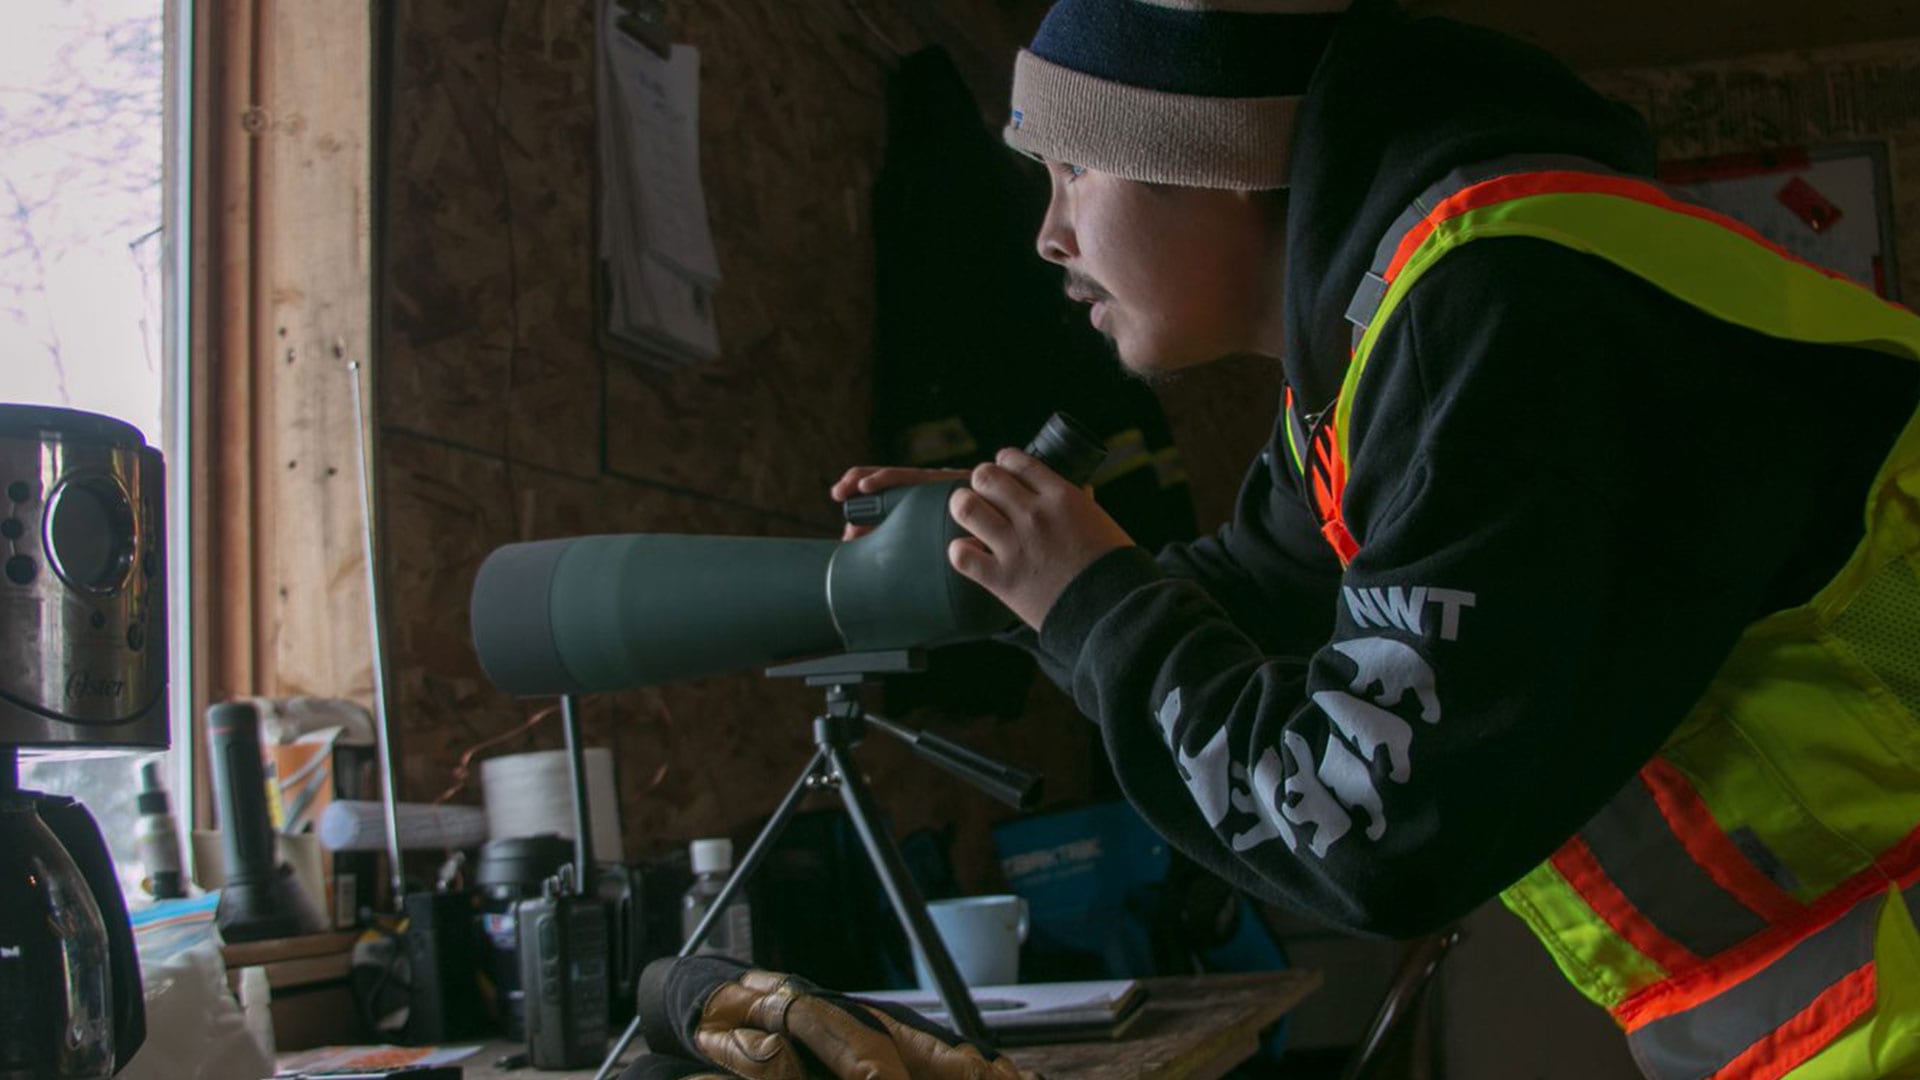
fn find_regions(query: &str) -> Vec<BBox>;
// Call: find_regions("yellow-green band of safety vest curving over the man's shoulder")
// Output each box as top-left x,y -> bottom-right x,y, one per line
1334,192 -> 1920,459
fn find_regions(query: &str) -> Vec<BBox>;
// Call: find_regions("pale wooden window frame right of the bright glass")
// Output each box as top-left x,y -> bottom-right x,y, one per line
185,0 -> 386,828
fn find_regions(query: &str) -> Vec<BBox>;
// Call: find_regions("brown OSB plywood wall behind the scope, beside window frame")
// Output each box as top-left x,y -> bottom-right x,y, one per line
378,0 -> 1152,886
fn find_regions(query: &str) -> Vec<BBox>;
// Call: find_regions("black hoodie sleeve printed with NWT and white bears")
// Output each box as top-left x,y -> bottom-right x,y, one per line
1039,240 -> 1896,936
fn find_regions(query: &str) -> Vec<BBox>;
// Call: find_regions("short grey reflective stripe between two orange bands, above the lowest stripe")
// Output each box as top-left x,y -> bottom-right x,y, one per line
1580,774 -> 1766,957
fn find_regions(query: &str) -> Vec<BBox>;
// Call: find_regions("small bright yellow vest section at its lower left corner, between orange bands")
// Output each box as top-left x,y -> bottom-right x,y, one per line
1500,863 -> 1667,1009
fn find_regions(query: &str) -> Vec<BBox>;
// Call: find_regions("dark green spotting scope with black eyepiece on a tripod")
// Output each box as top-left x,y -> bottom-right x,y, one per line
472,413 -> 1106,696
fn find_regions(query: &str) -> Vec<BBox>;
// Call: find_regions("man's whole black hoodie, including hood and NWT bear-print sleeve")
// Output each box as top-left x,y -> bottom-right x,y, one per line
1039,0 -> 1914,936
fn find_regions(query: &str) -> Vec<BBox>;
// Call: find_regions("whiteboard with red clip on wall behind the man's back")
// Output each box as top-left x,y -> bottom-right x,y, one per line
1661,142 -> 1899,300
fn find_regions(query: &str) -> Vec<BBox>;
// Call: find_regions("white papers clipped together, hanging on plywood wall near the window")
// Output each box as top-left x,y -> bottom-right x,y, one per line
599,4 -> 720,367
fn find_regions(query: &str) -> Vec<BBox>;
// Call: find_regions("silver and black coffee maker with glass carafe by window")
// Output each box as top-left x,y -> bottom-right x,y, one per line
0,404 -> 169,1080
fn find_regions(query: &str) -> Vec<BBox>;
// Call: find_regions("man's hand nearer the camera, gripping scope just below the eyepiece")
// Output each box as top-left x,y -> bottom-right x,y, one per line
948,448 -> 1133,630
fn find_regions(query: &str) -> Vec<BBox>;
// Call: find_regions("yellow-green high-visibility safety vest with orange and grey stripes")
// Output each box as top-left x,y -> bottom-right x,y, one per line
1286,158 -> 1920,1080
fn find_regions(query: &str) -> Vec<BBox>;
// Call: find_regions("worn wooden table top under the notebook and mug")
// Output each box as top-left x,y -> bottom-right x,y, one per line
461,970 -> 1321,1080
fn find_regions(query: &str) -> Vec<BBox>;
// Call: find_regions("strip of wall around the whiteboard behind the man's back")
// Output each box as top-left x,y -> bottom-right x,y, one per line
1590,38 -> 1920,304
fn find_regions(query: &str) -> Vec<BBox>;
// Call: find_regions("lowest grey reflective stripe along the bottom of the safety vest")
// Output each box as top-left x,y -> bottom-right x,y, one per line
1626,886 -> 1920,1080
